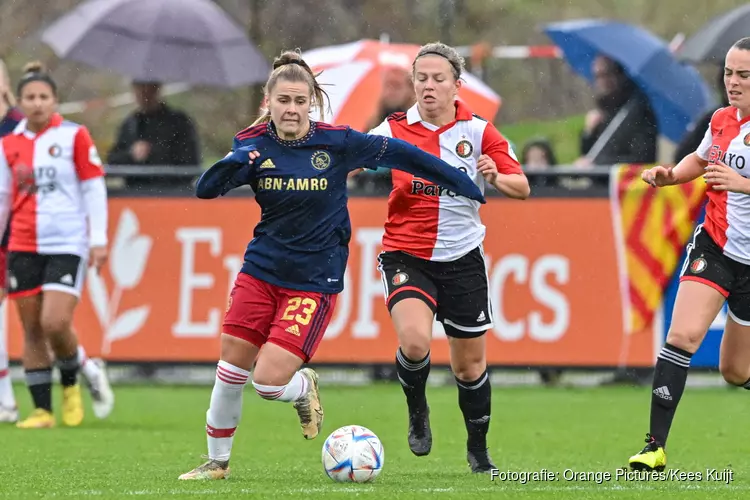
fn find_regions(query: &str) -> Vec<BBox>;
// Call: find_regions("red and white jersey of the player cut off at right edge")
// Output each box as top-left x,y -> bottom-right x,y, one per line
696,106 -> 750,265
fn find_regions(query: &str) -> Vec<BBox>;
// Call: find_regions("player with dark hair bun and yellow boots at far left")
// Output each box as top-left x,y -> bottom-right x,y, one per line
0,63 -> 113,428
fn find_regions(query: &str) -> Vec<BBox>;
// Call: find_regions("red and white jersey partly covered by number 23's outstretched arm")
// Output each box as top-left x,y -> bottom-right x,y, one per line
370,101 -> 522,262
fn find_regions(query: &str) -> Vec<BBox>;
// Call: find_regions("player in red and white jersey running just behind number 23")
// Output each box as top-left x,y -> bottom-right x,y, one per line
362,43 -> 530,473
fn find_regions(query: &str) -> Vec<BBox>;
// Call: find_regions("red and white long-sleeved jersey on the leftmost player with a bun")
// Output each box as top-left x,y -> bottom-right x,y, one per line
0,114 -> 107,258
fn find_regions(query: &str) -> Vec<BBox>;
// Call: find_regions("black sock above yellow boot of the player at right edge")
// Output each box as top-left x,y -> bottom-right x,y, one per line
651,344 -> 693,446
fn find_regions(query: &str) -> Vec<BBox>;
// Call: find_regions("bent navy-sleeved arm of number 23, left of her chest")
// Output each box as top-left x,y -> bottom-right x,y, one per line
195,146 -> 260,200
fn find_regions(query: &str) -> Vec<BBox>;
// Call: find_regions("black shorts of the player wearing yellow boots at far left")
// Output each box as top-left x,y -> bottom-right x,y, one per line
7,252 -> 88,298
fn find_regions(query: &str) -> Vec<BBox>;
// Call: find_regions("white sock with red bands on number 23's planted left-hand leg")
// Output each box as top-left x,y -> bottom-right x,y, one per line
206,361 -> 250,461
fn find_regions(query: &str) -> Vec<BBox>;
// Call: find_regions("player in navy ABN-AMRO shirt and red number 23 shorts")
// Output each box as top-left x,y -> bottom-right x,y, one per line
180,52 -> 485,479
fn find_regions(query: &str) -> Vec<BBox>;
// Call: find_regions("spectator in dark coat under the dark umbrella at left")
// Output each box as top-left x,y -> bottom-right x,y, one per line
107,81 -> 201,185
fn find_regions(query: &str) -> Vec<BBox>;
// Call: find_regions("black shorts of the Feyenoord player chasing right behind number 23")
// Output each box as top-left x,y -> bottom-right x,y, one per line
378,247 -> 493,338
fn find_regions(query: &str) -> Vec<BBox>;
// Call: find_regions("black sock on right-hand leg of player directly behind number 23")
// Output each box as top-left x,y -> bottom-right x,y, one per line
456,370 -> 492,450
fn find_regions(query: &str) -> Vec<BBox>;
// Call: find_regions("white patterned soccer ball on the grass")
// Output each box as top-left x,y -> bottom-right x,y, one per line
323,425 -> 385,483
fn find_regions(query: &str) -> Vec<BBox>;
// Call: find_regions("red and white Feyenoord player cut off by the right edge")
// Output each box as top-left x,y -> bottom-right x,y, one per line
629,38 -> 750,471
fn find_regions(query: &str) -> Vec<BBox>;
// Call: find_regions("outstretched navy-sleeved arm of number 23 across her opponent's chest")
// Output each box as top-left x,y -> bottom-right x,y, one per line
347,130 -> 487,203
